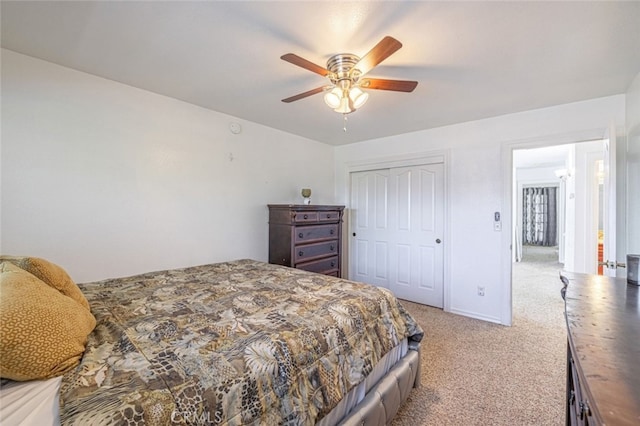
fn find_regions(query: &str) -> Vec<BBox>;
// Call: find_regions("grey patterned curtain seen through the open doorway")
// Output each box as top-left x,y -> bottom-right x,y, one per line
522,187 -> 558,246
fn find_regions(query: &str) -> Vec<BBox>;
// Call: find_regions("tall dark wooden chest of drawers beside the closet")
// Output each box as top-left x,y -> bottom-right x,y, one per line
269,204 -> 344,277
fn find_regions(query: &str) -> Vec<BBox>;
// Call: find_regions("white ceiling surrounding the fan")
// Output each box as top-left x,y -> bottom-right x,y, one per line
1,0 -> 640,145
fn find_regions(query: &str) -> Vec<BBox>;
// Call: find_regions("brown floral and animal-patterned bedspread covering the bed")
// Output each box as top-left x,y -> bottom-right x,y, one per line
60,260 -> 423,425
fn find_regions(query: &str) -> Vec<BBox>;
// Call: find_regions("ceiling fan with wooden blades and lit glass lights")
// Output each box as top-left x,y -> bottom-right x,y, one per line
280,36 -> 418,118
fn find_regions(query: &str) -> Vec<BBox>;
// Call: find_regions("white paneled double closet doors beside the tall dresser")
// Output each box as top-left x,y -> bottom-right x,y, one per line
350,164 -> 444,308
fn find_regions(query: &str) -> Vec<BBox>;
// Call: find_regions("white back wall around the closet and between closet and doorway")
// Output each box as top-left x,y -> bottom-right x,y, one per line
336,95 -> 625,324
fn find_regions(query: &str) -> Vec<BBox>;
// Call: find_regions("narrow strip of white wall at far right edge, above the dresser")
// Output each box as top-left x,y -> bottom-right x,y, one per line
618,73 -> 640,259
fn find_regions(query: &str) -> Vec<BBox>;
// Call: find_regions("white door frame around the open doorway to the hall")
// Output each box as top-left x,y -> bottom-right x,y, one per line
500,127 -> 608,326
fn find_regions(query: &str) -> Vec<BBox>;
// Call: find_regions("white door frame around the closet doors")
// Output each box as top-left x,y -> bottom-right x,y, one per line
341,150 -> 451,312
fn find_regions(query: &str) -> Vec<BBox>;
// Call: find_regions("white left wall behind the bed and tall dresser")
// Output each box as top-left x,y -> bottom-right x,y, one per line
0,50 -> 335,282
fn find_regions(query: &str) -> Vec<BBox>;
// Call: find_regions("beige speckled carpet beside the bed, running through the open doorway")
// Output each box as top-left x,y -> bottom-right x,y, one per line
392,247 -> 566,426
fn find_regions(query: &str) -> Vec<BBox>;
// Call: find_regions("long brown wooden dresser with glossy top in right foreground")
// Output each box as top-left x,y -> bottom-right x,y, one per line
560,271 -> 640,426
